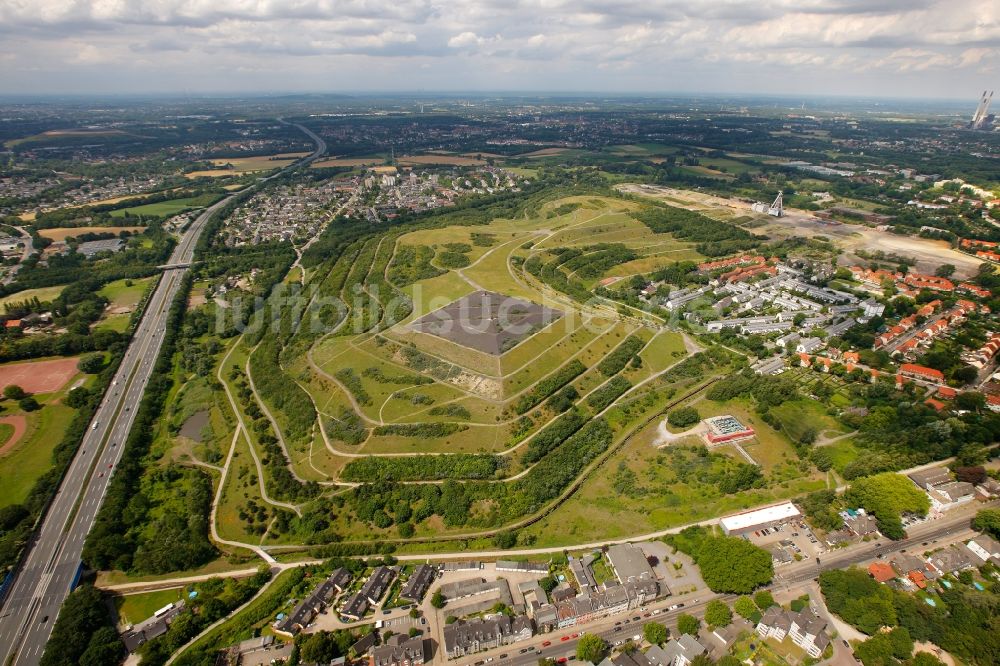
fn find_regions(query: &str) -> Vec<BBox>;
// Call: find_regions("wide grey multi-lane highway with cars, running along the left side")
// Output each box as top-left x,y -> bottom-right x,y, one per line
0,125 -> 326,666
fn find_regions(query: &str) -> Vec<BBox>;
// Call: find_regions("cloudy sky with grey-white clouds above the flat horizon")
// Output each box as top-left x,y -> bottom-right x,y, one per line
0,0 -> 1000,99
